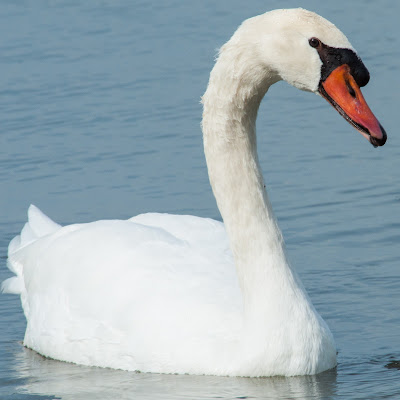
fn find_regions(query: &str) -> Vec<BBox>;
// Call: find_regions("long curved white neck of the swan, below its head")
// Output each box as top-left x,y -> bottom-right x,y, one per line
202,42 -> 306,319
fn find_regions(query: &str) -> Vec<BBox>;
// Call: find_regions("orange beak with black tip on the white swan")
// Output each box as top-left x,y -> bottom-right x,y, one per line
319,64 -> 387,147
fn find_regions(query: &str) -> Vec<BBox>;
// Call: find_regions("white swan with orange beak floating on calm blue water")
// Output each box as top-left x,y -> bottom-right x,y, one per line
2,9 -> 386,377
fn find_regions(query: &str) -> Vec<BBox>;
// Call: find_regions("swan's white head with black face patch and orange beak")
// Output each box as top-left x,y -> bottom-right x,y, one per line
232,9 -> 386,147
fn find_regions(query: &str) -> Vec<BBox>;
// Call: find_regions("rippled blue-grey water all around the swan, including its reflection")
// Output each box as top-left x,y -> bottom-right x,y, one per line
0,0 -> 400,400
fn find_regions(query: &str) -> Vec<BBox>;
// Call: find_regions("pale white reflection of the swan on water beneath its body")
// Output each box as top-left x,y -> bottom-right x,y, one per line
15,348 -> 336,400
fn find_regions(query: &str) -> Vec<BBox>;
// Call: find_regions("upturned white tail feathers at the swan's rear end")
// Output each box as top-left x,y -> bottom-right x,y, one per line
1,204 -> 61,294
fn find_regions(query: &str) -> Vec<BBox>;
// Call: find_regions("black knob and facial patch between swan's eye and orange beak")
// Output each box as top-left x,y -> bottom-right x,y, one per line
316,42 -> 369,87
